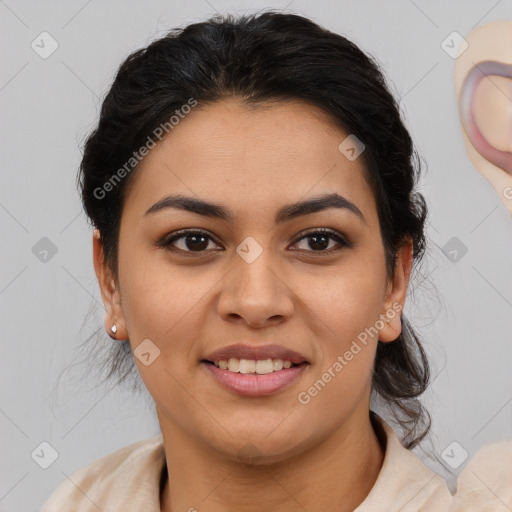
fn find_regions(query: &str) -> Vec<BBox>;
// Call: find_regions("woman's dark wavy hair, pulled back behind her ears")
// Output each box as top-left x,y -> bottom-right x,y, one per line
78,11 -> 430,447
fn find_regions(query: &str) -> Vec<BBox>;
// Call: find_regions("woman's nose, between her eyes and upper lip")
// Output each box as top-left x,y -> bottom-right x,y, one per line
217,245 -> 294,328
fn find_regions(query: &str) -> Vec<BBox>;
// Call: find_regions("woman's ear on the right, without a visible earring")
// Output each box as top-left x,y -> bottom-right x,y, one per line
378,238 -> 413,342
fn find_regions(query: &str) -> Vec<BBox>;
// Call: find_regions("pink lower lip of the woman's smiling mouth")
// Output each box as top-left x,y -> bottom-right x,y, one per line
201,361 -> 309,396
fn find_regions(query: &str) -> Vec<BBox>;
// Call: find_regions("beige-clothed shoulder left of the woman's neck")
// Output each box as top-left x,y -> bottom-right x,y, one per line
41,434 -> 165,512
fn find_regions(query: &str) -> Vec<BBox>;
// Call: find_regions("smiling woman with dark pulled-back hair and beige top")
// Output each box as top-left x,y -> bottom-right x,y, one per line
43,11 -> 451,512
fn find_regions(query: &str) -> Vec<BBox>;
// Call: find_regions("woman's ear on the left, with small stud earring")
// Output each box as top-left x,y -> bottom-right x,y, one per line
92,229 -> 128,340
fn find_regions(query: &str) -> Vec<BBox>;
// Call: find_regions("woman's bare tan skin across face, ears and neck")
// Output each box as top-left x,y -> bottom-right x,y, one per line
93,100 -> 412,512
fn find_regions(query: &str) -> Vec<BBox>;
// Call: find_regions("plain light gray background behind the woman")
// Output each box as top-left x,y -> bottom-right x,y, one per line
0,0 -> 512,511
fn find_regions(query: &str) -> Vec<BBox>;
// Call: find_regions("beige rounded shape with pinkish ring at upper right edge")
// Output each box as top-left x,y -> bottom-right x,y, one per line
455,21 -> 512,215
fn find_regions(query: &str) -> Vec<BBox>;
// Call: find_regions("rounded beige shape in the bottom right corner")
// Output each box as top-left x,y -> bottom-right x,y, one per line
451,439 -> 512,512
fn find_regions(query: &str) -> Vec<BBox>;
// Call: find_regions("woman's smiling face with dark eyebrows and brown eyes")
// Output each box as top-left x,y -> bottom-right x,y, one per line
94,100 -> 411,461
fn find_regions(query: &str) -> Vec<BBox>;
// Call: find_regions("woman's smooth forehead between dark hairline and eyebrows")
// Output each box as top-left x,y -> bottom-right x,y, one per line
120,100 -> 375,226
